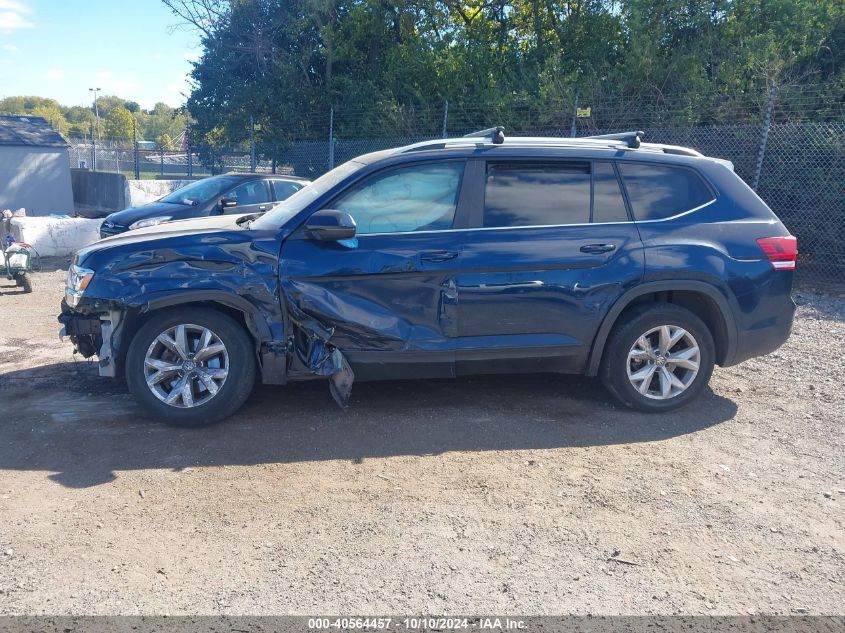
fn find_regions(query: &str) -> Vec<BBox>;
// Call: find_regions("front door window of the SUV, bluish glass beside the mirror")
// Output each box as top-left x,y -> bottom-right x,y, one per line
332,162 -> 464,235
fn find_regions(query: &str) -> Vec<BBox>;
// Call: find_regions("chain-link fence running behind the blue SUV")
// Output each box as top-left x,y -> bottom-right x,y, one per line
70,86 -> 845,288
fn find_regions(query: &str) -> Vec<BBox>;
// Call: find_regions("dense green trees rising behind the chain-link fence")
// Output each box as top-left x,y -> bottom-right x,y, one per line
163,0 -> 845,143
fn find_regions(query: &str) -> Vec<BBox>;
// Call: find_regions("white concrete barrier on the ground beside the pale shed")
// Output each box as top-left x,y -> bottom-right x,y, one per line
11,218 -> 102,257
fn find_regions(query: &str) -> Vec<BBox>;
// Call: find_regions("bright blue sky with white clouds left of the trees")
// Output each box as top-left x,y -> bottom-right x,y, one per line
0,0 -> 201,109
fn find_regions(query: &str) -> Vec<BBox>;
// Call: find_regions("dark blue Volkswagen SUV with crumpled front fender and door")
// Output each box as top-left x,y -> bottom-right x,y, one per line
59,128 -> 797,426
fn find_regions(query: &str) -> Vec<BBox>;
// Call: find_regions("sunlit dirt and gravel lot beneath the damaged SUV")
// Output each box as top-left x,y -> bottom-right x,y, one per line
0,263 -> 845,614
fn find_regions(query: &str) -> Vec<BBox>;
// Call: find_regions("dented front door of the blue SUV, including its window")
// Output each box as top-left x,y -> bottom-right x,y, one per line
280,161 -> 472,379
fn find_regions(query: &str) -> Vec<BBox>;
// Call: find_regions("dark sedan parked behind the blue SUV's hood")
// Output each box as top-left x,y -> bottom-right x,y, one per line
100,174 -> 309,237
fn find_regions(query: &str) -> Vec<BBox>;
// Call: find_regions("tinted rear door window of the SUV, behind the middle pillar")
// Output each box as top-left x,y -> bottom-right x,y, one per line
484,162 -> 590,227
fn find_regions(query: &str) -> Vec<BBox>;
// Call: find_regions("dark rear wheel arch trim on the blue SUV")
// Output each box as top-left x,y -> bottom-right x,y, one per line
586,280 -> 737,376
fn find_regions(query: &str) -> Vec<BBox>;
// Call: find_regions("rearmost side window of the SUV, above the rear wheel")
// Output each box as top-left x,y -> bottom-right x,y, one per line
619,162 -> 713,221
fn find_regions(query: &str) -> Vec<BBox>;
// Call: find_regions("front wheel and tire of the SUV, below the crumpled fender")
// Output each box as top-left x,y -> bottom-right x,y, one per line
125,308 -> 255,428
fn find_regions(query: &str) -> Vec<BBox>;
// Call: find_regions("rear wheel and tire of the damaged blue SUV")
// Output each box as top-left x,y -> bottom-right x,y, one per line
599,303 -> 716,413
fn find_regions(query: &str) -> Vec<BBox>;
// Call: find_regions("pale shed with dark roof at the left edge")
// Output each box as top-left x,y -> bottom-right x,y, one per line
0,116 -> 73,216
